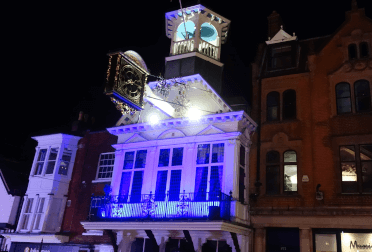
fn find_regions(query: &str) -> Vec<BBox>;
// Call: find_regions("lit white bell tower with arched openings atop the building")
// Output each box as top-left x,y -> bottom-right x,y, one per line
164,4 -> 230,94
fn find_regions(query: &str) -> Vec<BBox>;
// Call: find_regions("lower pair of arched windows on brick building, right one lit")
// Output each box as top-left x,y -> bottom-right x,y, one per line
266,150 -> 297,195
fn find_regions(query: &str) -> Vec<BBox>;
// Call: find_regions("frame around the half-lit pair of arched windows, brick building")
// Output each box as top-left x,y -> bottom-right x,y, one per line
264,148 -> 300,196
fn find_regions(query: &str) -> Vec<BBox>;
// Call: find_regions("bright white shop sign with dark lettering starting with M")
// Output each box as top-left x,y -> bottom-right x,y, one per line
341,233 -> 372,252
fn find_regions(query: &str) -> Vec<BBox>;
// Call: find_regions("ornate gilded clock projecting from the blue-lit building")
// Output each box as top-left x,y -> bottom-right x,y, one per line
105,51 -> 149,114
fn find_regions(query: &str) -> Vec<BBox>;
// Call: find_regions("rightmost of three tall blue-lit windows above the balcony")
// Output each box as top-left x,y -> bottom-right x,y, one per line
195,143 -> 225,201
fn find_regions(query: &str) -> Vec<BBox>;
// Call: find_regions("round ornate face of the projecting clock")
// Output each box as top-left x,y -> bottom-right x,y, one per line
119,65 -> 142,101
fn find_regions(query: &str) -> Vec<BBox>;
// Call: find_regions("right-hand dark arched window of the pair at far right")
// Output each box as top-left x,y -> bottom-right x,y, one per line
354,80 -> 371,112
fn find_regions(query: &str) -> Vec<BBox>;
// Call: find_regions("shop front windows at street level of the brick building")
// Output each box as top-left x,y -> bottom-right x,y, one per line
313,229 -> 372,252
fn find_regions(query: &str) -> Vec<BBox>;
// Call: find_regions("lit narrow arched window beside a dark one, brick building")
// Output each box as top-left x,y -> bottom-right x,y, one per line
283,150 -> 297,192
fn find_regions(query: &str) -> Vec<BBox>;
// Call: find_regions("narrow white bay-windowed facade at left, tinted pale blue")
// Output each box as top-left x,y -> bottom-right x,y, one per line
4,134 -> 80,248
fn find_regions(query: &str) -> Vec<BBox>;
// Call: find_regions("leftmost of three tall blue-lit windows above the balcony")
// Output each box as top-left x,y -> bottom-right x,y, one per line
119,150 -> 147,202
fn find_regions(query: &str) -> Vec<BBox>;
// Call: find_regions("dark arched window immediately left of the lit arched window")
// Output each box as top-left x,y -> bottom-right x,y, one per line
266,151 -> 280,195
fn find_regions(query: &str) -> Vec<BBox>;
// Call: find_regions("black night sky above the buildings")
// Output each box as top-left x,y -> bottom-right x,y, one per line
0,0 -> 372,170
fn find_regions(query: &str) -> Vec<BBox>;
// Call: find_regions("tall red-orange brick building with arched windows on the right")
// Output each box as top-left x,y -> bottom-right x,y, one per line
249,1 -> 372,252
